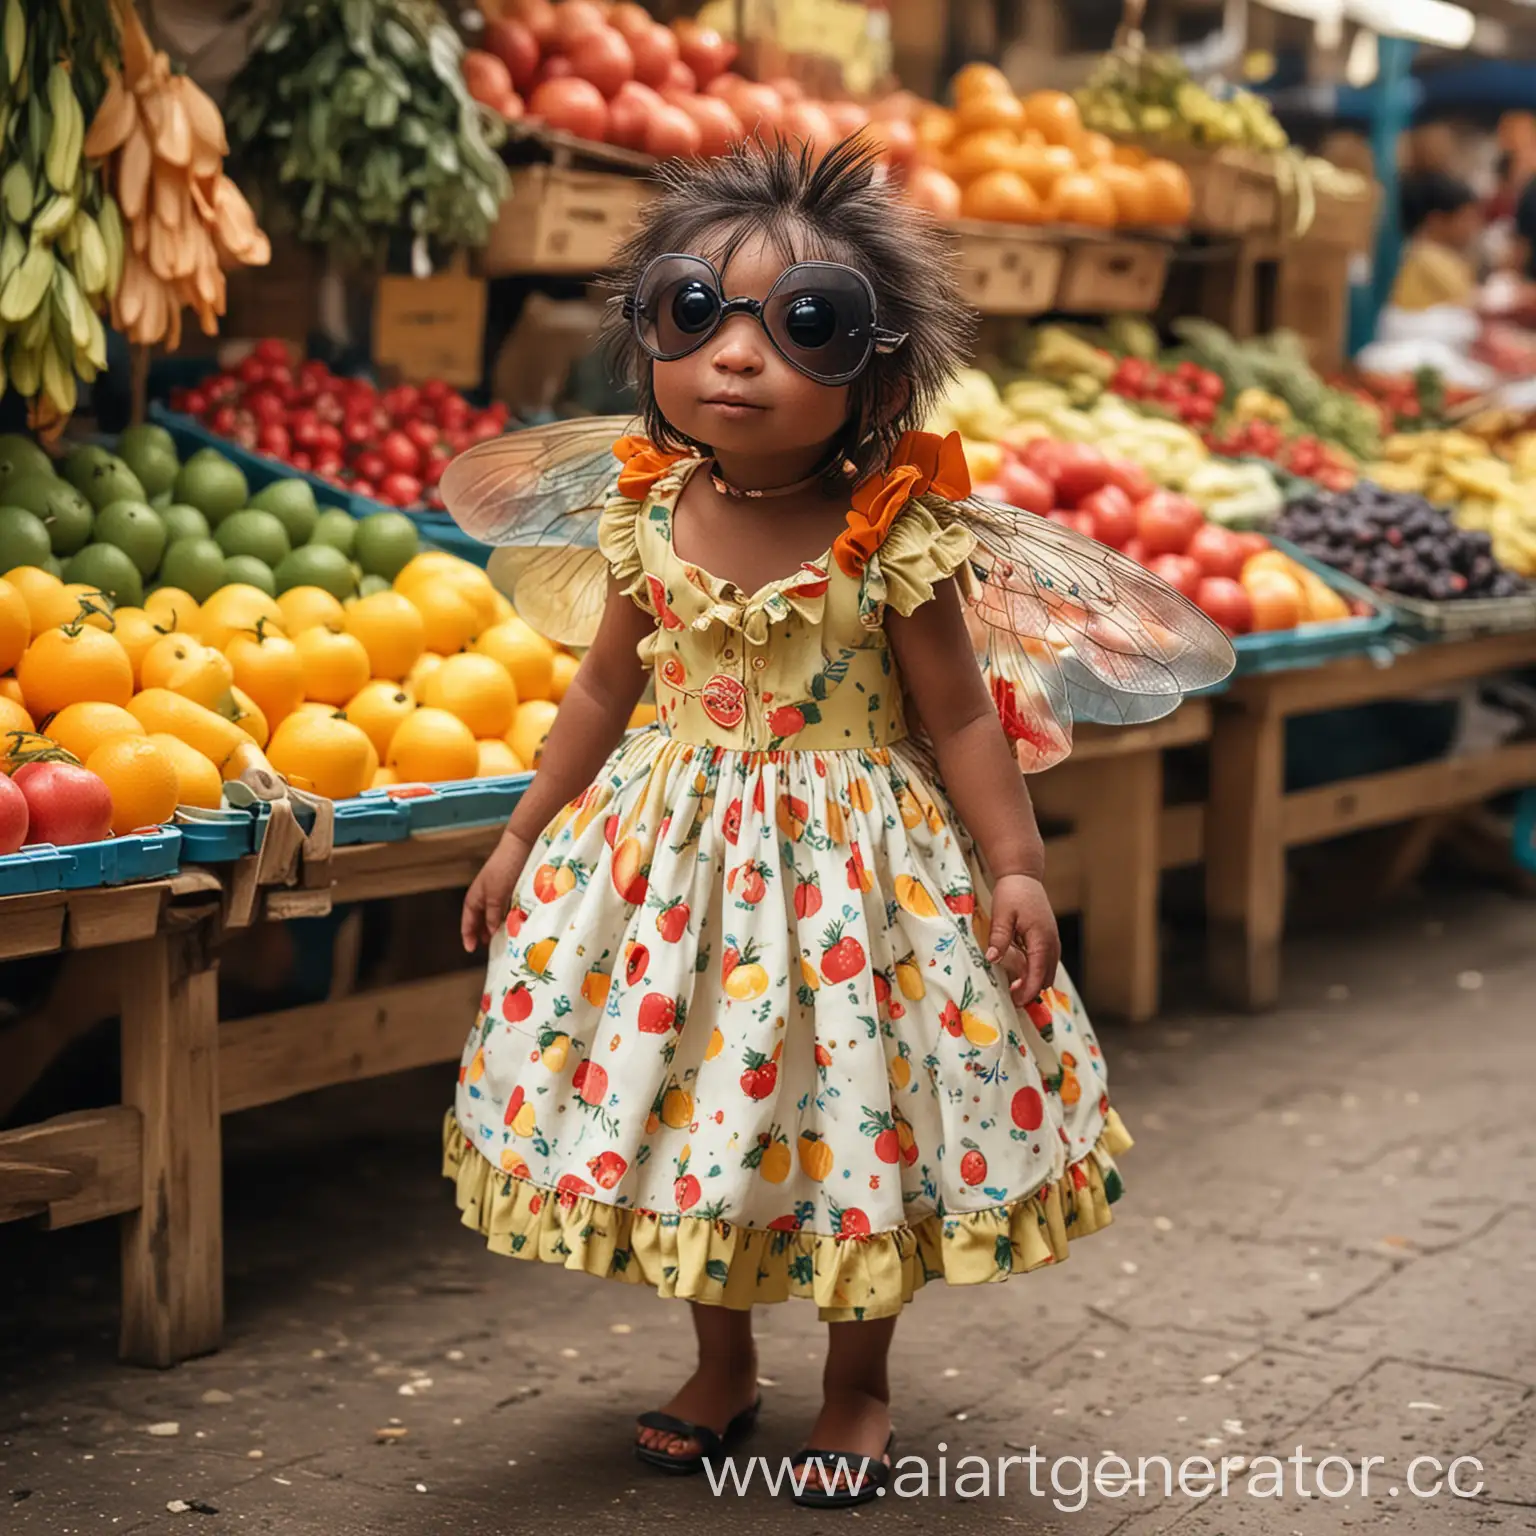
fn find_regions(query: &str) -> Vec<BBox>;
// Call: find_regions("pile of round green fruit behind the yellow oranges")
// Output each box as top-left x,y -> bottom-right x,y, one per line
0,425 -> 418,611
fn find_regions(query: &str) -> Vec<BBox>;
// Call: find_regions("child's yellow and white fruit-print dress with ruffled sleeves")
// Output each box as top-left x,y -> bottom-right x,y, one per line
444,433 -> 1130,1321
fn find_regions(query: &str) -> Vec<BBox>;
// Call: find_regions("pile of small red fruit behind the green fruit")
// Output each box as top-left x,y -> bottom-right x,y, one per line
170,339 -> 507,508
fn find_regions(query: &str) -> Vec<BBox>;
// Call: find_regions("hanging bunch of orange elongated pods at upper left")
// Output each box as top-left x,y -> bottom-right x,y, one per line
84,0 -> 272,352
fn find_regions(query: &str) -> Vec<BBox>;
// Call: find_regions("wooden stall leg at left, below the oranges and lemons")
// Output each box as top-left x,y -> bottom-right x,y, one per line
118,929 -> 224,1366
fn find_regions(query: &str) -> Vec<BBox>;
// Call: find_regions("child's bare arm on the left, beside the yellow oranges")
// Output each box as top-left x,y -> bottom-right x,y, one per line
459,584 -> 656,951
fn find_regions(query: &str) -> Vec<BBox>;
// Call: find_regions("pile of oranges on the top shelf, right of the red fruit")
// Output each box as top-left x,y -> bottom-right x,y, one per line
906,63 -> 1190,229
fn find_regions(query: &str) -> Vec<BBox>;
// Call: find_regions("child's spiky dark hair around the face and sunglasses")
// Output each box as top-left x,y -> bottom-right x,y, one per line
604,135 -> 975,476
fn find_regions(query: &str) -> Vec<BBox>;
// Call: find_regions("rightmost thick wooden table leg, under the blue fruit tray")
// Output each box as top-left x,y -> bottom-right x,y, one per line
1206,703 -> 1286,1011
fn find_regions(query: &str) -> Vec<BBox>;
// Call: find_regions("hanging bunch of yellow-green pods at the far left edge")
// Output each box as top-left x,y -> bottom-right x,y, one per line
0,0 -> 123,438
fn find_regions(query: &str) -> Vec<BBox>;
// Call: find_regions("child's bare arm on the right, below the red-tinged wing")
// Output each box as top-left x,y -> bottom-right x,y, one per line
886,581 -> 1061,998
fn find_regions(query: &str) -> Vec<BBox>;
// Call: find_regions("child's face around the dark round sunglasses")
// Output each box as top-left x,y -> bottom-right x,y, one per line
651,240 -> 848,473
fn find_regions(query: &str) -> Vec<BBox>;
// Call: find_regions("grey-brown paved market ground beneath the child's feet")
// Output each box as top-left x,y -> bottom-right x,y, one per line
0,894 -> 1536,1536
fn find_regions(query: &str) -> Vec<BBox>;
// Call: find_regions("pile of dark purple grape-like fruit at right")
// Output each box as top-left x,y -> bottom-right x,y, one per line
1276,481 -> 1528,602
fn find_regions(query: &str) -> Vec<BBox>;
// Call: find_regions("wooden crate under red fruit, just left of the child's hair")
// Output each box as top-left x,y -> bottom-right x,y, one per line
485,166 -> 651,276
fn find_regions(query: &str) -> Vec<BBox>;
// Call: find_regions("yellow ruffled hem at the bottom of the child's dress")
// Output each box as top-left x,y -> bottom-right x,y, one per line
442,1109 -> 1132,1322
